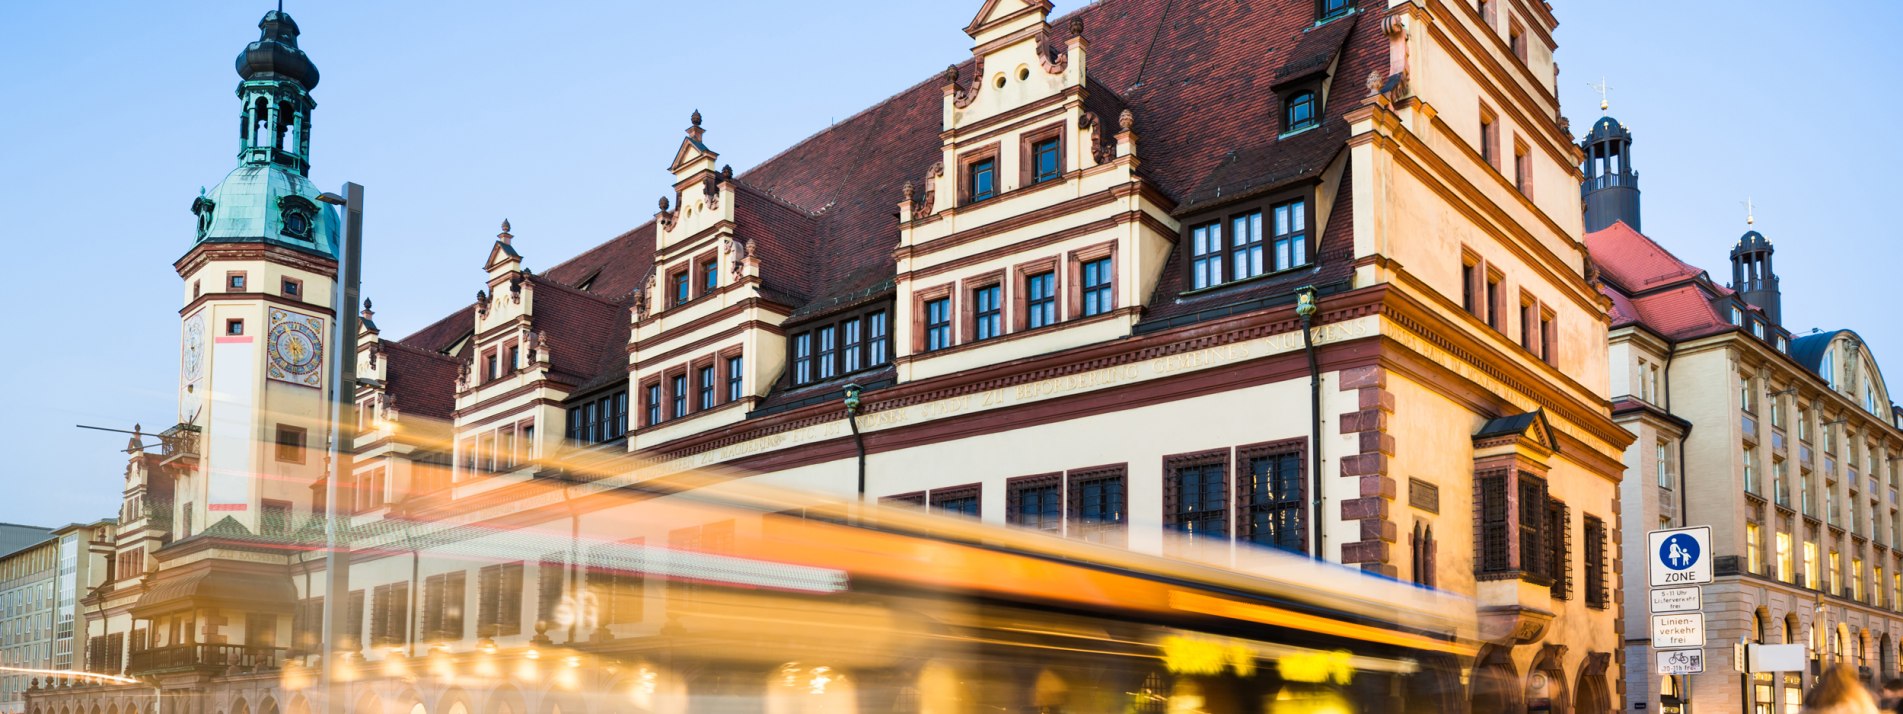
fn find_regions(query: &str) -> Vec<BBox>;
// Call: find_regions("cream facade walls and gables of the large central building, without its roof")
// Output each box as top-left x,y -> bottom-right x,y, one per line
40,0 -> 1631,712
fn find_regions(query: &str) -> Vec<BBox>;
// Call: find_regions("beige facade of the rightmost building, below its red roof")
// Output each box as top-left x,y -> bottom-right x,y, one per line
1612,327 -> 1903,710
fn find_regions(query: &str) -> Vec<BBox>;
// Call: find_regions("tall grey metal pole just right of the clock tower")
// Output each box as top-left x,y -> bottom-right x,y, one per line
320,183 -> 363,714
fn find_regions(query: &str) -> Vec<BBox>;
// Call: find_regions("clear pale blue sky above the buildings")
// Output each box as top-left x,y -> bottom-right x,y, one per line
0,0 -> 1903,526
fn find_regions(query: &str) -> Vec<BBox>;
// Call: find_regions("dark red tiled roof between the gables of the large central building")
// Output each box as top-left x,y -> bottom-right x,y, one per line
386,0 -> 1387,403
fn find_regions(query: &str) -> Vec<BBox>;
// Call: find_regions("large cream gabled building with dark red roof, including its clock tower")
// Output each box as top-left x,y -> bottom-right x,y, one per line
48,0 -> 1631,712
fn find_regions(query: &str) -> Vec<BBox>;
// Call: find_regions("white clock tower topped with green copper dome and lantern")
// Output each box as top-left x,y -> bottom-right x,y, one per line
171,11 -> 339,539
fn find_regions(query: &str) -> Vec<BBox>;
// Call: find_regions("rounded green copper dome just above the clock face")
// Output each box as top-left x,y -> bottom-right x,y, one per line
192,164 -> 341,259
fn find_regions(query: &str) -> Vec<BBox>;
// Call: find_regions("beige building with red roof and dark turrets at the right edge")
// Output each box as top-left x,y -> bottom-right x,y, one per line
1583,118 -> 1903,712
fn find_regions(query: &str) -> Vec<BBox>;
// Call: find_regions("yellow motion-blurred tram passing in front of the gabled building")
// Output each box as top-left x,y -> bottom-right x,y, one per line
510,481 -> 1475,714
